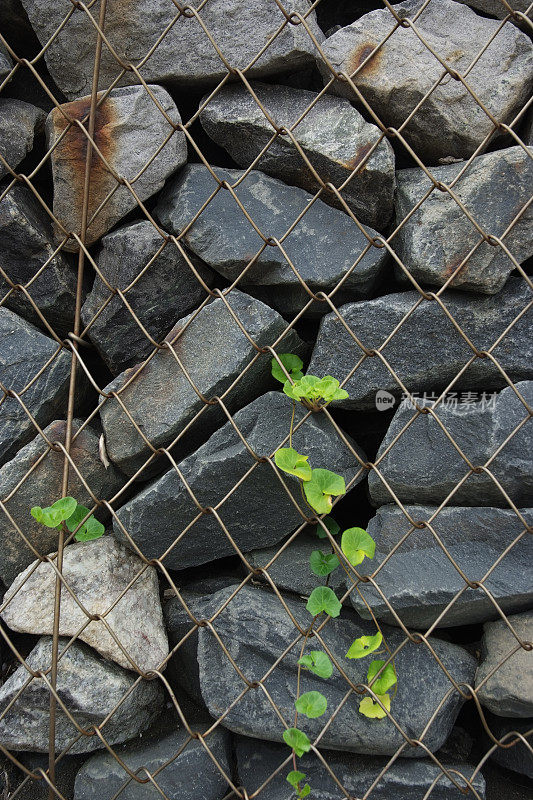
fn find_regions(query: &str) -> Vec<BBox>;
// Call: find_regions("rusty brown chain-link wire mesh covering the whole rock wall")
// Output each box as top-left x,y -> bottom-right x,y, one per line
0,0 -> 533,800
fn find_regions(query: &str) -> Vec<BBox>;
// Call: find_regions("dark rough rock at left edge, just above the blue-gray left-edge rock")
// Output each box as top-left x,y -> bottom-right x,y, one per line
0,186 -> 76,336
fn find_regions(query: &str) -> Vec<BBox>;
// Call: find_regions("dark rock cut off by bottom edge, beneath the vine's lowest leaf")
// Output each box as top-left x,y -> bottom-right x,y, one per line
235,737 -> 485,800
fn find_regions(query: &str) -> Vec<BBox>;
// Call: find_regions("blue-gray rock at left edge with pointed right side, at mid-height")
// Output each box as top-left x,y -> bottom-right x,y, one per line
0,308 -> 71,463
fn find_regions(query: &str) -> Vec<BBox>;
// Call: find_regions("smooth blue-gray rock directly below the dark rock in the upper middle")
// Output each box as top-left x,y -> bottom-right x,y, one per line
155,164 -> 387,316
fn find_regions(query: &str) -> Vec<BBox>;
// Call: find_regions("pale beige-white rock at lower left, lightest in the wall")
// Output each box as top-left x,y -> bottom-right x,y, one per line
2,536 -> 168,672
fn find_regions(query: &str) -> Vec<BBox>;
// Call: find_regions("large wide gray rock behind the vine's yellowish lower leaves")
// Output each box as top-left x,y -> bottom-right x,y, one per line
167,587 -> 475,757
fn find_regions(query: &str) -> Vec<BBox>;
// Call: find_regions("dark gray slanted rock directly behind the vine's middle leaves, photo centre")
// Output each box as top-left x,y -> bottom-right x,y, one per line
114,392 -> 365,569
